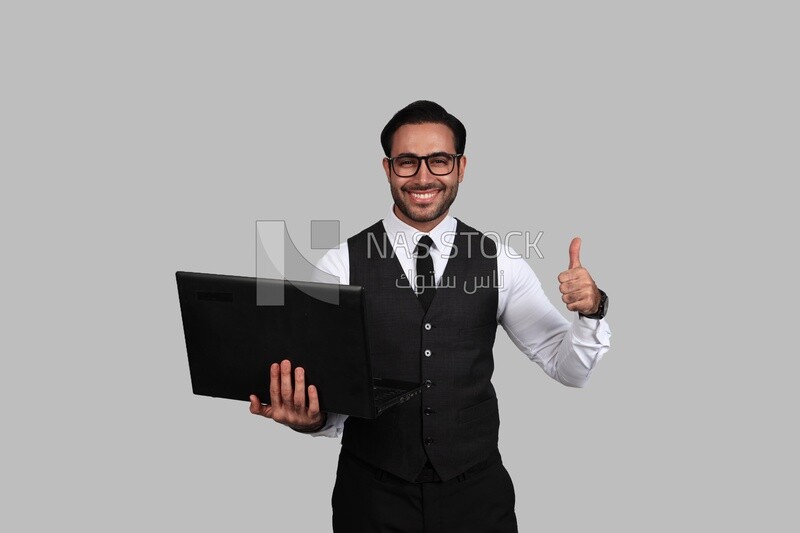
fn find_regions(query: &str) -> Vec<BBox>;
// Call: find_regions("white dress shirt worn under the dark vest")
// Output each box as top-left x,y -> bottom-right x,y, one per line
311,208 -> 611,437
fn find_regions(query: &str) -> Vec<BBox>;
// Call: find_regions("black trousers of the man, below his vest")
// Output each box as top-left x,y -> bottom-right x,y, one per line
331,448 -> 518,533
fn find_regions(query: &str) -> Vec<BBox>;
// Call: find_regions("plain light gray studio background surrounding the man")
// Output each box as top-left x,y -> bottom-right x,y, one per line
0,1 -> 800,532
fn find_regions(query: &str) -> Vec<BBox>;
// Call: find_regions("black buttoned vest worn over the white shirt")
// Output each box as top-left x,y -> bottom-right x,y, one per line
342,220 -> 500,481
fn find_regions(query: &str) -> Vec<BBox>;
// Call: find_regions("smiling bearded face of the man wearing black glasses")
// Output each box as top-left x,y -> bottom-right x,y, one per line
383,123 -> 467,231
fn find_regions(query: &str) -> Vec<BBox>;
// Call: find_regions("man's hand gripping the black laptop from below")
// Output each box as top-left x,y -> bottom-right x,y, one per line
250,359 -> 327,432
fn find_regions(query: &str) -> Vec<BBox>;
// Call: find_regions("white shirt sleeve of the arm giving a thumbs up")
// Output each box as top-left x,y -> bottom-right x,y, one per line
498,245 -> 611,387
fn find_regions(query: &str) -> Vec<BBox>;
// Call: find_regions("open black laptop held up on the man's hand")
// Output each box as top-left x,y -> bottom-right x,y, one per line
175,272 -> 422,418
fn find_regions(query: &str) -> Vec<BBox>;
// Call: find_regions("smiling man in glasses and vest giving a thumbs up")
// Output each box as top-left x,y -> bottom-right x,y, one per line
250,101 -> 610,533
